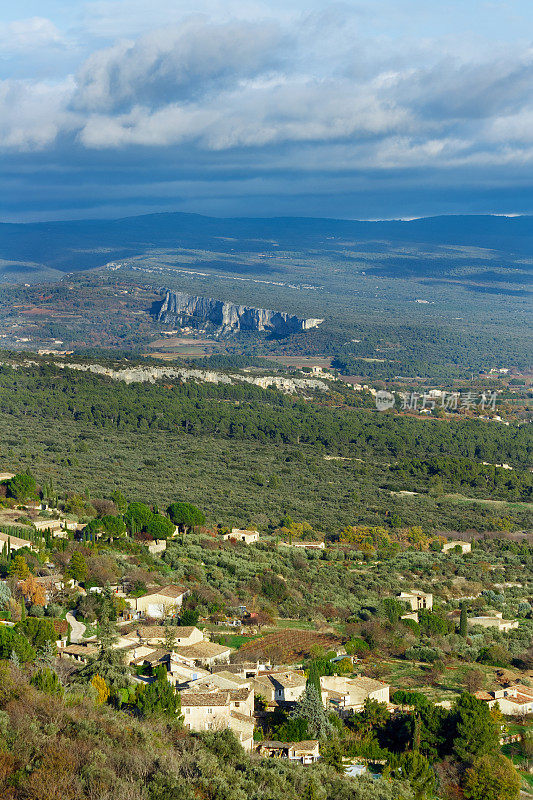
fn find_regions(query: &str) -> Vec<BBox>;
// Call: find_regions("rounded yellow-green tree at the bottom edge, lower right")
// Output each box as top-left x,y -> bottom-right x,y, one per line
463,755 -> 521,800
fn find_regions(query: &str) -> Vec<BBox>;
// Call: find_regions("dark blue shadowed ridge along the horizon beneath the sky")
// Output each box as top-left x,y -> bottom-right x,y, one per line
0,213 -> 533,273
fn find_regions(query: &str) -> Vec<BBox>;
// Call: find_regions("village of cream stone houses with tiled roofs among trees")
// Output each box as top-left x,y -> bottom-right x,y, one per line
0,462 -> 533,792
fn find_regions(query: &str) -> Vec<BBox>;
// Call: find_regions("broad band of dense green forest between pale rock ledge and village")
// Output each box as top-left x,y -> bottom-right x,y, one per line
0,365 -> 532,533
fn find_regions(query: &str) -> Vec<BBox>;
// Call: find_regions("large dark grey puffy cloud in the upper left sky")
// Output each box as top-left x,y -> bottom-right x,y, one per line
72,18 -> 289,113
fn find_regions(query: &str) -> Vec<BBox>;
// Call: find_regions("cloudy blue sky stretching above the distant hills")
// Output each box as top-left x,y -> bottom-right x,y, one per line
0,0 -> 533,222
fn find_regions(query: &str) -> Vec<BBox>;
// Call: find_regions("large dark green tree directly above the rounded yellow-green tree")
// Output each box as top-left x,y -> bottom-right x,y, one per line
453,692 -> 499,762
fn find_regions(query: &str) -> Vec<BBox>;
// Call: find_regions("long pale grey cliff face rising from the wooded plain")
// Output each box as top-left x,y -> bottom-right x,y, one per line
154,292 -> 323,334
